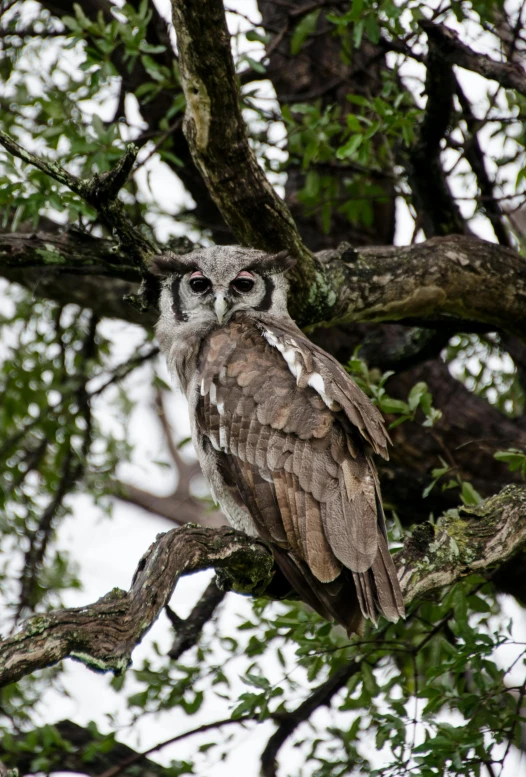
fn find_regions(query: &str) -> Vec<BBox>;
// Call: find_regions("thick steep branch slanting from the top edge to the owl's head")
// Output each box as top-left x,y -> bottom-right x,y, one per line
172,0 -> 344,321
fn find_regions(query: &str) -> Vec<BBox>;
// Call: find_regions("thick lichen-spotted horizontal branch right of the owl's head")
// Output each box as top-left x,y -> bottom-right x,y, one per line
318,235 -> 526,338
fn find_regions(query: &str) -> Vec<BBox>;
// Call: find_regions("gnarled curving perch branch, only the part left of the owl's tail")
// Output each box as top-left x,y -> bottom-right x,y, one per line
0,524 -> 273,687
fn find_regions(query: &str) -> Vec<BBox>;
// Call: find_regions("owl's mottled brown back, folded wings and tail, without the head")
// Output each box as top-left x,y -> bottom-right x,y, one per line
198,318 -> 403,631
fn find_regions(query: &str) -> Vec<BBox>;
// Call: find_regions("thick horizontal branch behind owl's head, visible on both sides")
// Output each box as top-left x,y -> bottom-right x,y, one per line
4,233 -> 526,339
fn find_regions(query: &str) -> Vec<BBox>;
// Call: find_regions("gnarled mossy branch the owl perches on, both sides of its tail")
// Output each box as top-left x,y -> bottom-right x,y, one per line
0,486 -> 526,686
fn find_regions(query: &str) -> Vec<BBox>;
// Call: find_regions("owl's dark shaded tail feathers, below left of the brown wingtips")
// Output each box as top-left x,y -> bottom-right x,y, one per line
271,544 -> 363,637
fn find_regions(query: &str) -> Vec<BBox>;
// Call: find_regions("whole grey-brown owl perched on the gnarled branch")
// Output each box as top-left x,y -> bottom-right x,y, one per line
155,246 -> 404,634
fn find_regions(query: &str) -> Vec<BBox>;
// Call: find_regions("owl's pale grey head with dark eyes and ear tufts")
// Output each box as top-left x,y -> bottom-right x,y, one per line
153,246 -> 295,327
